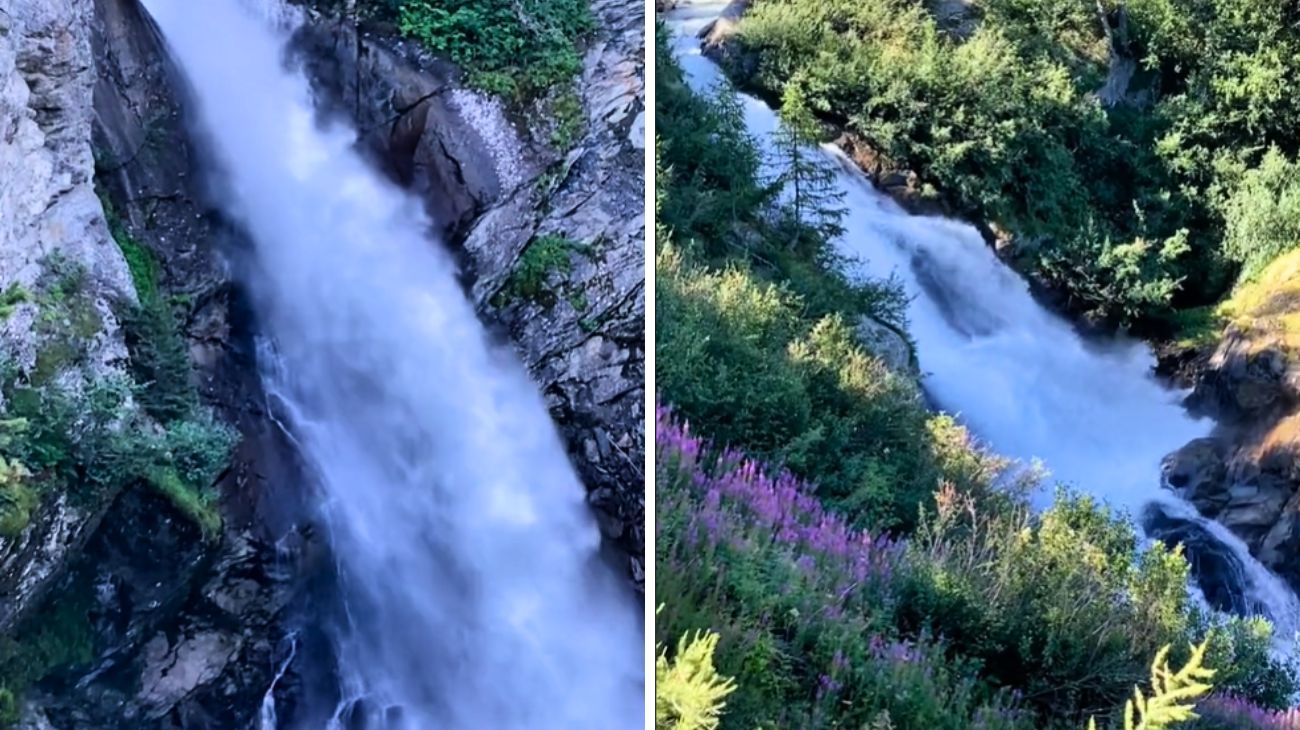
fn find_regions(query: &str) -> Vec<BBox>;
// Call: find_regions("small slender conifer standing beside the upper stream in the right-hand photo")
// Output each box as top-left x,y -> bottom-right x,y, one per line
774,81 -> 846,240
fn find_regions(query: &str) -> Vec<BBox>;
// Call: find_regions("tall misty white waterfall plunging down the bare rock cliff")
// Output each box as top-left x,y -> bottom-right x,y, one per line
146,0 -> 644,730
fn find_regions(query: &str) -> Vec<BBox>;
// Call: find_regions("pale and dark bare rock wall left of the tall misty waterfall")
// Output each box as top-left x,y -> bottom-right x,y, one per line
0,0 -> 298,730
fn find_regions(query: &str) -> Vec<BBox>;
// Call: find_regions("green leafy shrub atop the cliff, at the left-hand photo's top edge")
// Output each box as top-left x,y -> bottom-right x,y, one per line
398,0 -> 594,99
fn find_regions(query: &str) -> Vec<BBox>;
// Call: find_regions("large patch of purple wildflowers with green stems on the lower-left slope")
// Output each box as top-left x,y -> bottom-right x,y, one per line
655,408 -> 1032,730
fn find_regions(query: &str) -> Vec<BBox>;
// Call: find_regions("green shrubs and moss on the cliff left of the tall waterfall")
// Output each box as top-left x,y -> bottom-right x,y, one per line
0,207 -> 235,727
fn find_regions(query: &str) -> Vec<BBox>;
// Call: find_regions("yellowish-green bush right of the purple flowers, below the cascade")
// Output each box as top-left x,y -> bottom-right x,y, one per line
898,485 -> 1191,717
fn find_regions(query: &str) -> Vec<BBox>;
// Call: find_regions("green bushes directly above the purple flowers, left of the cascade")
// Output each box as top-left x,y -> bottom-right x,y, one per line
655,245 -> 941,526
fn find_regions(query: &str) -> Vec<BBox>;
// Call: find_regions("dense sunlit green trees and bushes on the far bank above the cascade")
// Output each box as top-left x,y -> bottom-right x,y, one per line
733,0 -> 1300,327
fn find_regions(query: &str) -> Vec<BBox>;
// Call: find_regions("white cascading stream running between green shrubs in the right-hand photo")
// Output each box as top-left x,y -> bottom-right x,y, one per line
670,0 -> 1300,651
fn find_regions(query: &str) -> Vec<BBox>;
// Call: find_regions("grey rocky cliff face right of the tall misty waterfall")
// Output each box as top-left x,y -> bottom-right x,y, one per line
295,0 -> 646,586
